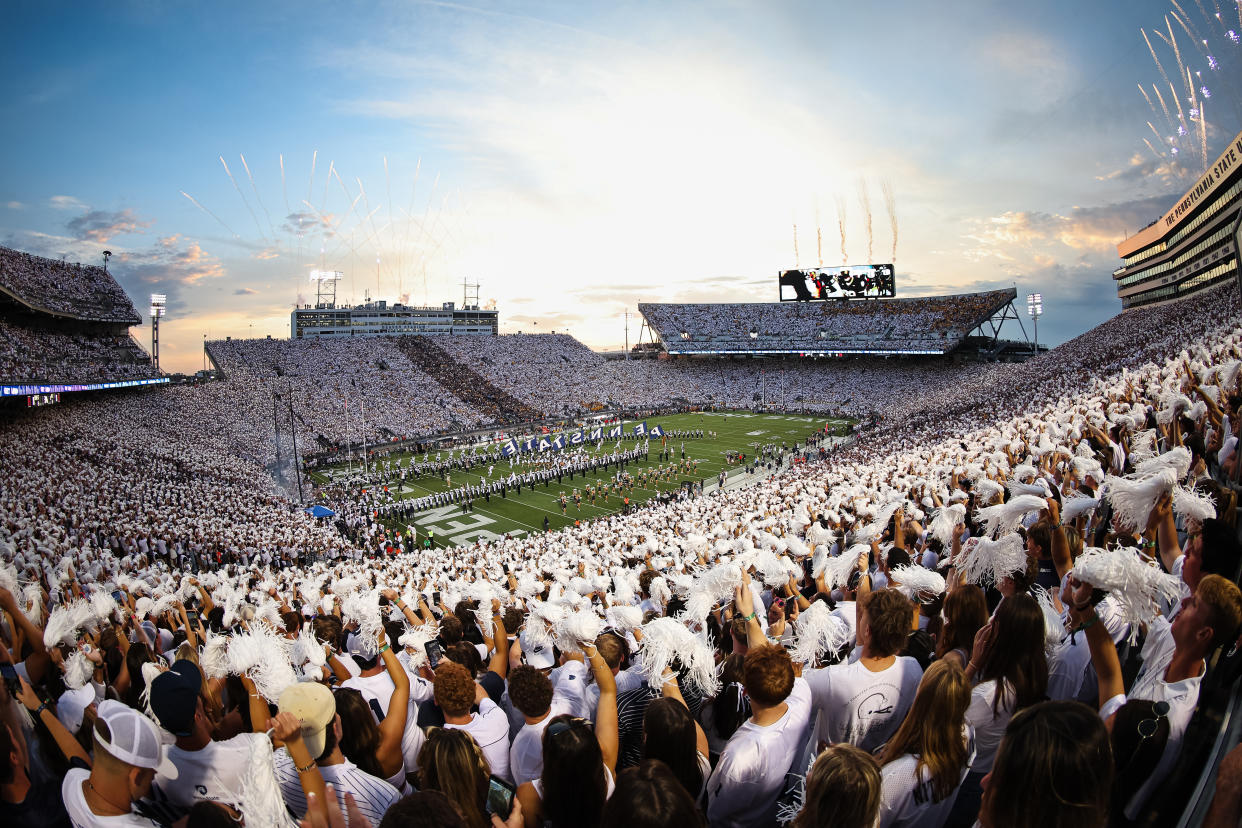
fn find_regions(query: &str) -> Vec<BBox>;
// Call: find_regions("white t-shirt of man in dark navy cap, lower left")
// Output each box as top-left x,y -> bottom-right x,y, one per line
150,734 -> 267,822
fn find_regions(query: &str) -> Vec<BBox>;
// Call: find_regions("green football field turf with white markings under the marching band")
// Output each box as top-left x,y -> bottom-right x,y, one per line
312,413 -> 851,546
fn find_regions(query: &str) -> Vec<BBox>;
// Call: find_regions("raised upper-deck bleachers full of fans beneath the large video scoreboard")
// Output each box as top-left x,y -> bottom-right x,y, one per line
638,288 -> 1017,355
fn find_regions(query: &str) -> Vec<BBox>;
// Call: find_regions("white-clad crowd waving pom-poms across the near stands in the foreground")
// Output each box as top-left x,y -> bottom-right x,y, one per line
0,278 -> 1242,828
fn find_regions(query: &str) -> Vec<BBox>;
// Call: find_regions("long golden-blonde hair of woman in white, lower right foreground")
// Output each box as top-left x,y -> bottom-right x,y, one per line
879,662 -> 970,802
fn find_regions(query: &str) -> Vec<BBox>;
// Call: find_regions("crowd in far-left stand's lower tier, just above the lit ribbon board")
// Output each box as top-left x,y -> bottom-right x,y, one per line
0,319 -> 156,382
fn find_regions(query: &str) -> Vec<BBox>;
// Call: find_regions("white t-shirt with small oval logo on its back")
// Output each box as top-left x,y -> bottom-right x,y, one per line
806,655 -> 923,754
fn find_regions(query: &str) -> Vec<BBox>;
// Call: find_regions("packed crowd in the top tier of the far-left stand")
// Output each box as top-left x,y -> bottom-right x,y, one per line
0,247 -> 142,325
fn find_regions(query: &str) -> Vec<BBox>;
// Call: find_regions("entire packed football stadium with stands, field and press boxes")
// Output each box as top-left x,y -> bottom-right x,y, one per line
0,6 -> 1242,828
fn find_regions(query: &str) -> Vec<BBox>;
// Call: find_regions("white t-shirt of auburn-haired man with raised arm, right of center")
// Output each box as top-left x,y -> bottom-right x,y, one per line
707,678 -> 812,828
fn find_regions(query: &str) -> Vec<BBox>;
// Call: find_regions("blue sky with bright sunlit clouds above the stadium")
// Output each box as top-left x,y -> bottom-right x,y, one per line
0,0 -> 1242,371
